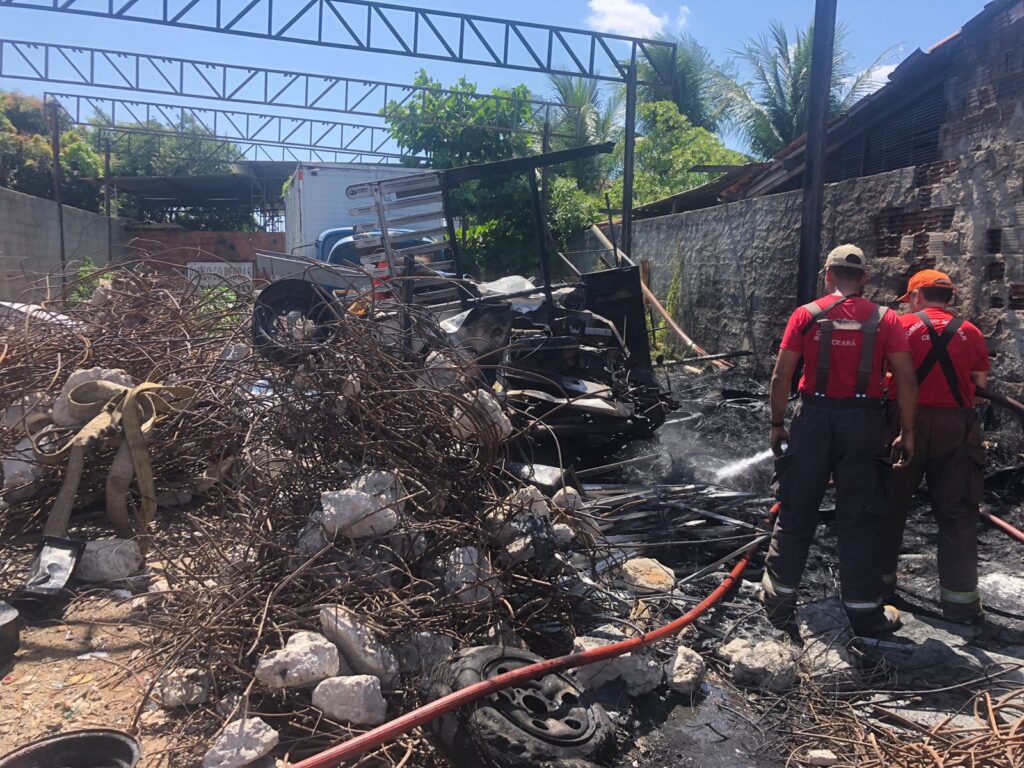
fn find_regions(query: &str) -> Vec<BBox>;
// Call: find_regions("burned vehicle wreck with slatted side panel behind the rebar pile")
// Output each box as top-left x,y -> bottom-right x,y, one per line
253,144 -> 675,464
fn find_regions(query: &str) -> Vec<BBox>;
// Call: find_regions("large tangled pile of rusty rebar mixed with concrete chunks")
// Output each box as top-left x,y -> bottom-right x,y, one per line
0,265 -> 598,766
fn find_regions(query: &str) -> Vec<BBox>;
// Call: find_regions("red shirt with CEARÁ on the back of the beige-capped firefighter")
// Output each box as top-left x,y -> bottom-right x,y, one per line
781,293 -> 909,399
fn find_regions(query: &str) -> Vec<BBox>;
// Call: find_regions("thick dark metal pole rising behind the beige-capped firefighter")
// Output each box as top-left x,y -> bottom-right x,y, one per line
797,0 -> 837,304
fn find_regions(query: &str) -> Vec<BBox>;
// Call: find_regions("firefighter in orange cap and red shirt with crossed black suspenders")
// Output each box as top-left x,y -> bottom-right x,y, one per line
883,269 -> 991,623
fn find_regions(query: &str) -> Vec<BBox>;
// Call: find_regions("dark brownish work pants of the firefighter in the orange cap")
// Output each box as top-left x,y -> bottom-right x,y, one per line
882,408 -> 985,617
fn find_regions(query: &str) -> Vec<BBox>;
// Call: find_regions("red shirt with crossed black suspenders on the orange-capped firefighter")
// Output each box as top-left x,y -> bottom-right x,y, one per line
889,307 -> 992,408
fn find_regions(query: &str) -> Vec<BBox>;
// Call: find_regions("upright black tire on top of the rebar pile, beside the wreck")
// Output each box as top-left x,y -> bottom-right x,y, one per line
253,280 -> 342,366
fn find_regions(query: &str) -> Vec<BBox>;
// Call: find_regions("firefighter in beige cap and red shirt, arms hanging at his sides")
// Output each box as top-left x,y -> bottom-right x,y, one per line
762,245 -> 918,636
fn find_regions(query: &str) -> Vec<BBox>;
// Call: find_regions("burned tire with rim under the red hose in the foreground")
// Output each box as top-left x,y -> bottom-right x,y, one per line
431,645 -> 614,768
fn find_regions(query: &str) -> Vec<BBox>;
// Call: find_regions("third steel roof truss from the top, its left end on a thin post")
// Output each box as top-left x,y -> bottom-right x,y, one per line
44,93 -> 417,160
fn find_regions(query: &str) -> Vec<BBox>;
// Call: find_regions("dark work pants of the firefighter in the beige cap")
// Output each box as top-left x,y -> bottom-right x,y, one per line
766,399 -> 889,631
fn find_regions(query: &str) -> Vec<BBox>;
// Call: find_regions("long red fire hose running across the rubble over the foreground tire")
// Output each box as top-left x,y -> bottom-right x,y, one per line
291,503 -> 779,768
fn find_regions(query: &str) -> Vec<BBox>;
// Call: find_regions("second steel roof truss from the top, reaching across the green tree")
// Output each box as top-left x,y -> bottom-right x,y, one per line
0,40 -> 582,138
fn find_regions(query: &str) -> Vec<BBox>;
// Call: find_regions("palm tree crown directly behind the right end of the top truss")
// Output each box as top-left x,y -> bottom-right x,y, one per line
639,35 -> 736,133
